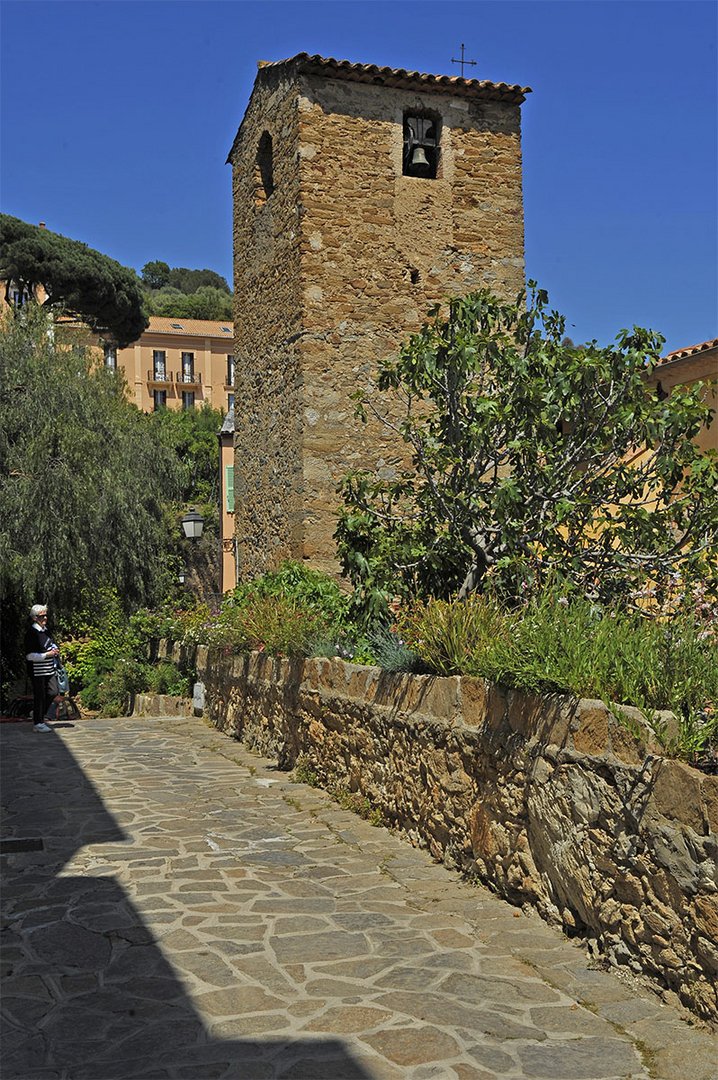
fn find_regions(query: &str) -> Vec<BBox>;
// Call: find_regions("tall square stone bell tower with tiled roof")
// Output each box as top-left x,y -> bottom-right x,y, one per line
228,53 -> 529,580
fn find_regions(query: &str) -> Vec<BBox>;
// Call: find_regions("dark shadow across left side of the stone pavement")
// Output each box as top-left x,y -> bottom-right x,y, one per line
0,725 -> 370,1080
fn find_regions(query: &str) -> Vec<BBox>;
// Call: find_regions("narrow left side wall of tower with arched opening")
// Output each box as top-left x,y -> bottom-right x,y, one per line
230,69 -> 303,579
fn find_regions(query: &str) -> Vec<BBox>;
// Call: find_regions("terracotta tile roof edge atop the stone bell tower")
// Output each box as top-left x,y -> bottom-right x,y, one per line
257,53 -> 531,104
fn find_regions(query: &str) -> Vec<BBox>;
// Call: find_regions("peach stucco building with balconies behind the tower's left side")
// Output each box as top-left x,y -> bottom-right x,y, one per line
105,315 -> 234,413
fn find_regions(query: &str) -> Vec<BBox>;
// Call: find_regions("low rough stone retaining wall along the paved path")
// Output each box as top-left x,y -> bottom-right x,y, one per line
183,649 -> 718,1021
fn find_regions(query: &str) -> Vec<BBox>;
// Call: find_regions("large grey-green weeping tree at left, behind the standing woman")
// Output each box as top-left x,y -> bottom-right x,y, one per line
0,307 -> 182,639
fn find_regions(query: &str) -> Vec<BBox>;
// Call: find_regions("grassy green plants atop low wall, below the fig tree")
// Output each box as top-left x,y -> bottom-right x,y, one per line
398,588 -> 718,760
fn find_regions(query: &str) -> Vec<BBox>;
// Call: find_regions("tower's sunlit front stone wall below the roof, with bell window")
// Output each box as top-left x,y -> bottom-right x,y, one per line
299,78 -> 524,569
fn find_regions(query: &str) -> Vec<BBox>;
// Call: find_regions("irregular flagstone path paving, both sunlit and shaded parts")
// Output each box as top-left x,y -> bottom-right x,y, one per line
0,717 -> 718,1080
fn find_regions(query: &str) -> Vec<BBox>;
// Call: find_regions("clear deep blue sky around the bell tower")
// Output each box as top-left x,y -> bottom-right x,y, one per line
0,0 -> 718,350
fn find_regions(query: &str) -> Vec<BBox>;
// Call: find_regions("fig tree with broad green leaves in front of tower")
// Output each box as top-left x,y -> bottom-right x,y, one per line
336,283 -> 718,623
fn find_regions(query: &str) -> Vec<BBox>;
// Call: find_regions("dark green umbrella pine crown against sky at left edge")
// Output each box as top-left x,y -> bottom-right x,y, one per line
0,214 -> 148,348
